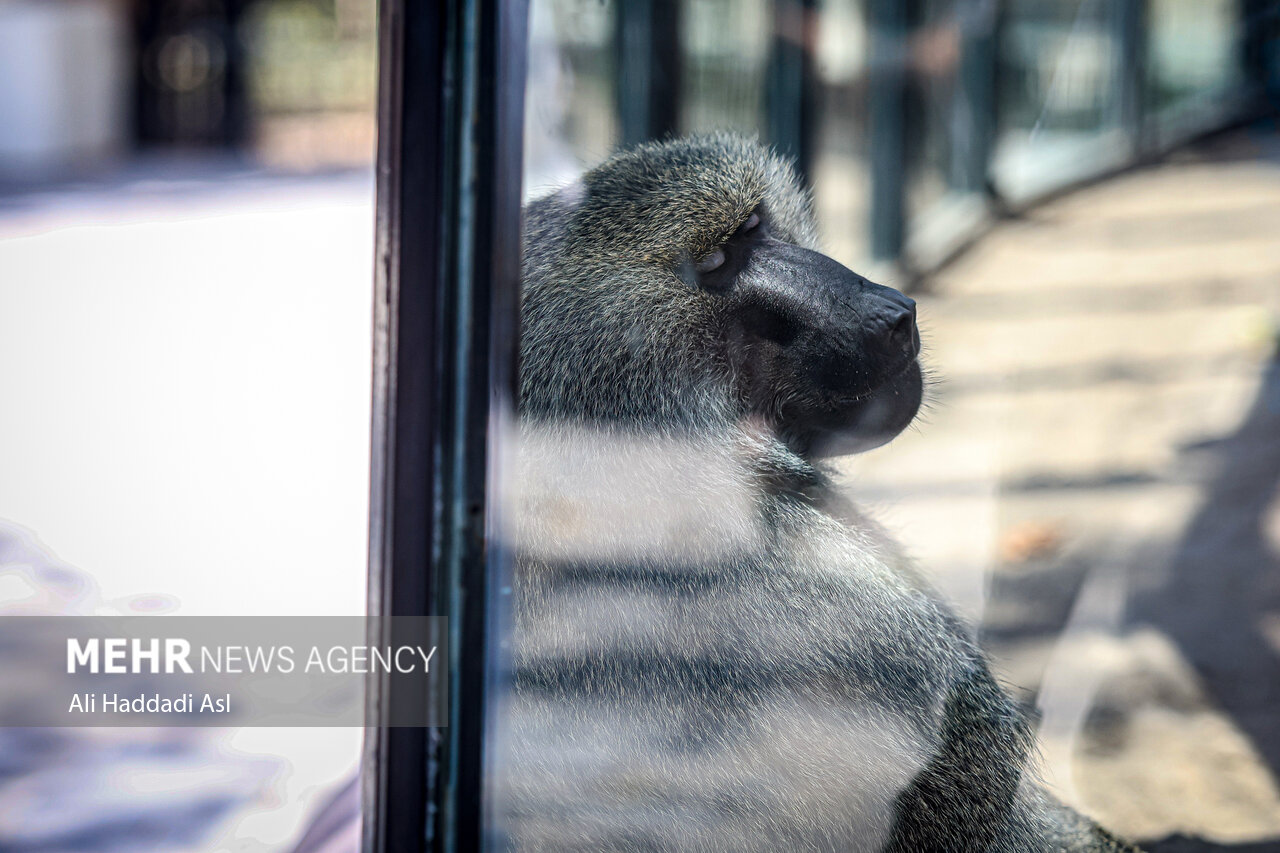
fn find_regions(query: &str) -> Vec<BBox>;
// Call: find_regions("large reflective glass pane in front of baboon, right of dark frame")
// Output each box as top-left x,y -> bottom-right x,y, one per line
490,0 -> 1280,853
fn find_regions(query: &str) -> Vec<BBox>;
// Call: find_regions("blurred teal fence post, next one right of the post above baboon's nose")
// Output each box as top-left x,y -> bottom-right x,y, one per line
951,0 -> 996,192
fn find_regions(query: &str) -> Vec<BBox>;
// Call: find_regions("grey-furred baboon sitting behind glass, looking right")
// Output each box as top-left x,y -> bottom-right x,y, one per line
492,134 -> 1135,853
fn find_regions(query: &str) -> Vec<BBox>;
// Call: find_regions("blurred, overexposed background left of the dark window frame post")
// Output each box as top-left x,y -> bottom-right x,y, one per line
0,0 -> 376,853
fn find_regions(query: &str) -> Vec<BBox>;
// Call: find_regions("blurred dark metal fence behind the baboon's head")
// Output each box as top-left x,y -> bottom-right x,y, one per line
530,0 -> 1280,270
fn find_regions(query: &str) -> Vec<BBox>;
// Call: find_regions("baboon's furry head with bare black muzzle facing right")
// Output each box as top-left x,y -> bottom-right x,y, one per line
522,134 -> 923,456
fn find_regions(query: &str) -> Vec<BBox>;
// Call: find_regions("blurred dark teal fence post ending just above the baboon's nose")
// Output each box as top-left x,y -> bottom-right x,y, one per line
867,0 -> 909,261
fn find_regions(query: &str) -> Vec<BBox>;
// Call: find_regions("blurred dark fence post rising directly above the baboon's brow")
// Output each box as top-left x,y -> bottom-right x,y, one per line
765,0 -> 818,183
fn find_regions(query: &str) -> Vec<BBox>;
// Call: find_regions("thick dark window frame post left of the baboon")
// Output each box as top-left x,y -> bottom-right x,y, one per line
362,0 -> 527,853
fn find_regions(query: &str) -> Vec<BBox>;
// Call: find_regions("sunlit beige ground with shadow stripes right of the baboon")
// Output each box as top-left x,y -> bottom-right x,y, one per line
846,131 -> 1280,853
